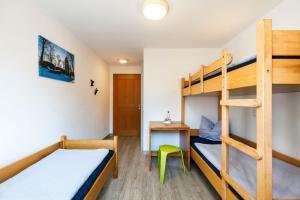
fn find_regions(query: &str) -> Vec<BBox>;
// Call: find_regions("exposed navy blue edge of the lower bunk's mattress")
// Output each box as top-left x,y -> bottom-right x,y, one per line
190,136 -> 243,199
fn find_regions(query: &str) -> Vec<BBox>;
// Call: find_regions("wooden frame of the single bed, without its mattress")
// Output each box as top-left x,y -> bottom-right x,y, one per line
0,136 -> 118,200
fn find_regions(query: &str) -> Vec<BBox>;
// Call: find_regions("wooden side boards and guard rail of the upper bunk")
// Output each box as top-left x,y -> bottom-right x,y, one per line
182,28 -> 300,96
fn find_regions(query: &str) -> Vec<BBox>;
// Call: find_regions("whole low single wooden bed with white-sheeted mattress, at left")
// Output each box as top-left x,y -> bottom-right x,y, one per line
0,136 -> 118,200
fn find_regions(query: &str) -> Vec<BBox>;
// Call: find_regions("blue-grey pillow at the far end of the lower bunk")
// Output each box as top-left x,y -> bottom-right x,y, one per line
199,116 -> 222,141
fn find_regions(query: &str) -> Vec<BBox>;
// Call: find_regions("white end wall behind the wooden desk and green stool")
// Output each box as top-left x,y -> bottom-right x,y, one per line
143,48 -> 221,151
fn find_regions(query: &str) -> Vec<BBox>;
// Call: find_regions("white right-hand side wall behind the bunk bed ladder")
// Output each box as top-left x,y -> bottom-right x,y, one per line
224,0 -> 300,159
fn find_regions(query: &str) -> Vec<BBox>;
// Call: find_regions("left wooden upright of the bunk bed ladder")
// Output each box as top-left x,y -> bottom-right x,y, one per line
221,49 -> 229,200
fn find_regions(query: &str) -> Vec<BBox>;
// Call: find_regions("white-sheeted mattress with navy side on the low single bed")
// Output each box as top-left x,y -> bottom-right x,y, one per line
0,149 -> 114,200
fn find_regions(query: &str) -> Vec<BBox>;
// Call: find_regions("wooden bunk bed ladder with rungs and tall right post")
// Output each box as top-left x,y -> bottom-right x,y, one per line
220,20 -> 272,200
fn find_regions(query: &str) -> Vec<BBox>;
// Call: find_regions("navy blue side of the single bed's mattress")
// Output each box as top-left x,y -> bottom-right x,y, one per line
72,150 -> 114,200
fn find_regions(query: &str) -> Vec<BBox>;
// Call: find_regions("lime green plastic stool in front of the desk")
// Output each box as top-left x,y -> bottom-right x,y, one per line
157,145 -> 186,184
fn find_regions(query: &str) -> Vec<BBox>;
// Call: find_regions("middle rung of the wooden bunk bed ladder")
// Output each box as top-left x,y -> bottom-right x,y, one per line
221,136 -> 262,160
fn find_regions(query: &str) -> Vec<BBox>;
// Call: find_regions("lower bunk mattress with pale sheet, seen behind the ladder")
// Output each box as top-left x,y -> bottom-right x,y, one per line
191,137 -> 300,199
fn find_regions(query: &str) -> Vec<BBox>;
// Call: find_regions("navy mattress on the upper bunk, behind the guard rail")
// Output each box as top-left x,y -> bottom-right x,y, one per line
185,56 -> 300,87
